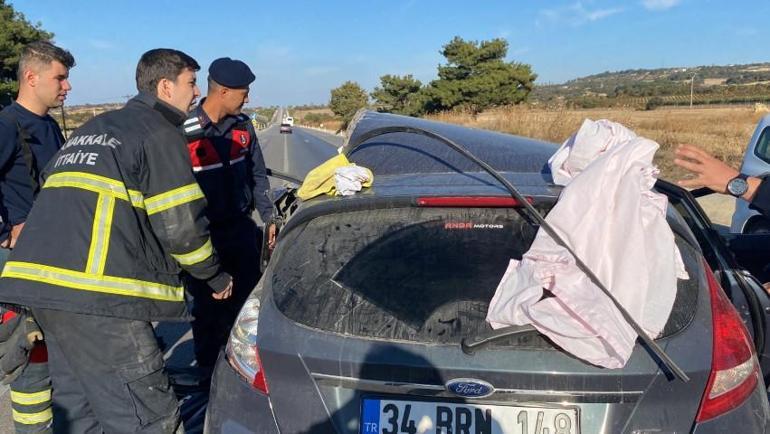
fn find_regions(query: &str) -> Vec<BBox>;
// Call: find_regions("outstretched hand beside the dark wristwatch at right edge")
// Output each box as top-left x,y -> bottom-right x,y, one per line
674,145 -> 738,193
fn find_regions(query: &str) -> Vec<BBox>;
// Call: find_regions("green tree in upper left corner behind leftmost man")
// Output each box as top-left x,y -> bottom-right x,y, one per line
0,0 -> 53,104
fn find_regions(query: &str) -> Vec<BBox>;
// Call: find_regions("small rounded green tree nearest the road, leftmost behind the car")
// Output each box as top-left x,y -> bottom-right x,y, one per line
371,74 -> 424,116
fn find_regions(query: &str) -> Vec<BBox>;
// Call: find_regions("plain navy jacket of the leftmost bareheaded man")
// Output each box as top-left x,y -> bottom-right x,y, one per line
0,102 -> 64,241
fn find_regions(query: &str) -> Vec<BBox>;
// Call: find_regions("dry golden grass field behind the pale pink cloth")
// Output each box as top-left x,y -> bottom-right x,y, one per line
428,106 -> 765,180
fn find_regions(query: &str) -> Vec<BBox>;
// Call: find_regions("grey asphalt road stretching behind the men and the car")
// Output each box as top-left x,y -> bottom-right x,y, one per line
0,124 -> 342,434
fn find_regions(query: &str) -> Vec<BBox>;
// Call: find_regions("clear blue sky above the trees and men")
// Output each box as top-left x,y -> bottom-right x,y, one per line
8,0 -> 770,106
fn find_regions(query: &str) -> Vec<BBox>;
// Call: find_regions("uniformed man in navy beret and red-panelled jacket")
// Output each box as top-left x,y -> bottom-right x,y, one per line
184,57 -> 272,368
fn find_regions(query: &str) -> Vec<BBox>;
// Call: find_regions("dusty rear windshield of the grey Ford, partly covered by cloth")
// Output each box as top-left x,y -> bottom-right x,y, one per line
272,208 -> 699,348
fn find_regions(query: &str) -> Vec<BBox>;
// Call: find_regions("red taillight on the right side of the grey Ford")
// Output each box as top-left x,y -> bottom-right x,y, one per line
695,265 -> 759,422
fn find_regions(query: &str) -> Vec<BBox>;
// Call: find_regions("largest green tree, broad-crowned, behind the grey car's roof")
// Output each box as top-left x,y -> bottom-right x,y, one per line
424,36 -> 537,113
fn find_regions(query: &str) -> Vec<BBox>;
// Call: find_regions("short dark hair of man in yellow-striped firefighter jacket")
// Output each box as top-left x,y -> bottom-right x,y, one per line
136,48 -> 201,95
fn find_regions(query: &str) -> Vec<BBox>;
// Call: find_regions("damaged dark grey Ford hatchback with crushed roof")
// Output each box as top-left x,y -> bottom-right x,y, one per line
205,112 -> 770,434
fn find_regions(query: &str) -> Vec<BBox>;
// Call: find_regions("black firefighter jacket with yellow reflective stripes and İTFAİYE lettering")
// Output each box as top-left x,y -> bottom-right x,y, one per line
0,94 -> 230,320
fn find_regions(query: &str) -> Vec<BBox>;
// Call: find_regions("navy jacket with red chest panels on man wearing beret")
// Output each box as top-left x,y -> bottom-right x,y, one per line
184,102 -> 273,225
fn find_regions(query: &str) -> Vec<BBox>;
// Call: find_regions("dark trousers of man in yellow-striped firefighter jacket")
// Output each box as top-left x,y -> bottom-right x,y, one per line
33,309 -> 184,434
